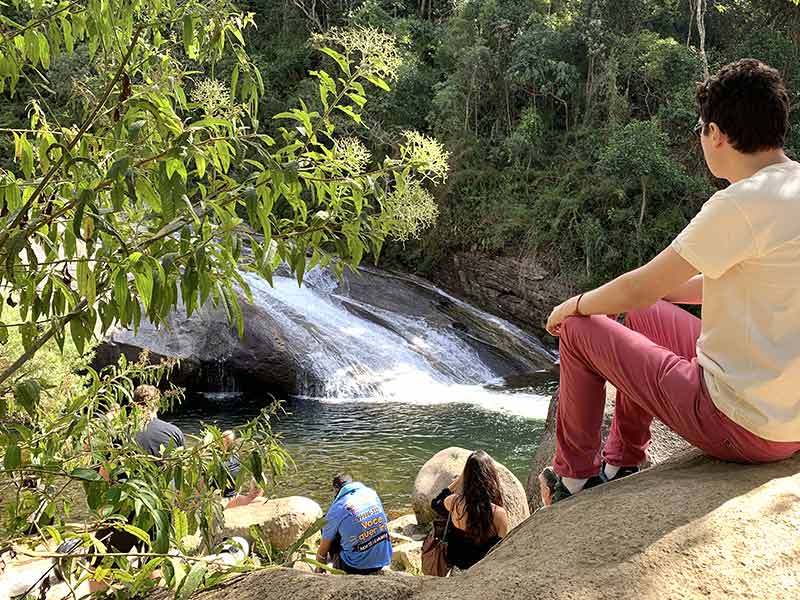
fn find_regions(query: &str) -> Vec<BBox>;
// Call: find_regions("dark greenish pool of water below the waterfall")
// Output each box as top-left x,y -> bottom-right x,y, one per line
165,394 -> 544,511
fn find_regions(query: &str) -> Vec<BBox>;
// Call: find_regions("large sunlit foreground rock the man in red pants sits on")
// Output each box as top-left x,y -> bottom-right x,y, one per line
184,451 -> 800,600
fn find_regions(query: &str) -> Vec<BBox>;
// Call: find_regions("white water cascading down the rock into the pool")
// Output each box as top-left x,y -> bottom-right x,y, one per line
245,269 -> 547,417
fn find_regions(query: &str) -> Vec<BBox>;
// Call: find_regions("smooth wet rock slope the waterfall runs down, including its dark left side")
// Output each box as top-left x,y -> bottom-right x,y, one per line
94,269 -> 554,397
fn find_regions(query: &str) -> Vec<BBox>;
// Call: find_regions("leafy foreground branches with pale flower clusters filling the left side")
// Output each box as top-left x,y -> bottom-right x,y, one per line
0,0 -> 448,597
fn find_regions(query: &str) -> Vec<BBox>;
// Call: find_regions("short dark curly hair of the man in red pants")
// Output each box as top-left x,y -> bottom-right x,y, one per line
696,58 -> 789,154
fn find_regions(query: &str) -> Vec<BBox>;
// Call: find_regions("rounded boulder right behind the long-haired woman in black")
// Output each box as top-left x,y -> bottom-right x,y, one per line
411,447 -> 530,527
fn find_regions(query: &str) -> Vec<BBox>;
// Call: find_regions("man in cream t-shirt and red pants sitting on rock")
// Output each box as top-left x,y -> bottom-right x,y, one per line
539,59 -> 800,505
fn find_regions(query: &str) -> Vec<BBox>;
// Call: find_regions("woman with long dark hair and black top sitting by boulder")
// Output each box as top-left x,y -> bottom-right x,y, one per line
431,450 -> 508,570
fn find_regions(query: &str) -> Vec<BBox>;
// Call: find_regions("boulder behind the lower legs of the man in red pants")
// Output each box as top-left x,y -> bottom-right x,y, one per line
526,384 -> 692,512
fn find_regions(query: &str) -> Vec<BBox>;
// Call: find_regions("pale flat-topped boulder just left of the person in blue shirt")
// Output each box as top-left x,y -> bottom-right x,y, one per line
224,496 -> 323,550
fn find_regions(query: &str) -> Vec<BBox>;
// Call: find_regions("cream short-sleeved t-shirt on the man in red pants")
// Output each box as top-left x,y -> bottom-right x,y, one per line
672,162 -> 800,442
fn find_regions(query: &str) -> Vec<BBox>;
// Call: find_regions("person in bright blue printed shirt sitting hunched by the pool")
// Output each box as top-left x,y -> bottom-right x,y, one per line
317,473 -> 392,575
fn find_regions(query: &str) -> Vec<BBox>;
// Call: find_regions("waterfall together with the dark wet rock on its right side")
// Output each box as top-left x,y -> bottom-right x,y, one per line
245,269 -> 554,415
